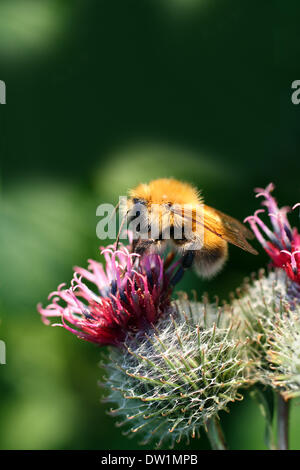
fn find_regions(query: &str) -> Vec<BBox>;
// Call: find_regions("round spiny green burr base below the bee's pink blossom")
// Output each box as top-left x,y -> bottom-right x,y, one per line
102,301 -> 249,448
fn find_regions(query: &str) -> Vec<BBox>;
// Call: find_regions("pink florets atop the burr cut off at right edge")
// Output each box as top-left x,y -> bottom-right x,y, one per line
245,183 -> 300,290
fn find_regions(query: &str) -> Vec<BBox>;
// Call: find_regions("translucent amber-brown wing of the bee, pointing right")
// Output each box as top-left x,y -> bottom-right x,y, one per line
170,205 -> 257,255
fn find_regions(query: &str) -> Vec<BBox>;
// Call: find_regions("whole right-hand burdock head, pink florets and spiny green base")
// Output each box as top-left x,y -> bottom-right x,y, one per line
231,184 -> 300,398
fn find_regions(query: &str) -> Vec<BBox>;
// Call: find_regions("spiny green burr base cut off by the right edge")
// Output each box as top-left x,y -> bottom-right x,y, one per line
230,269 -> 300,399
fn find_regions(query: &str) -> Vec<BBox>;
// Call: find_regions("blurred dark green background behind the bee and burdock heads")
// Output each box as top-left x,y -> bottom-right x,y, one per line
0,0 -> 300,449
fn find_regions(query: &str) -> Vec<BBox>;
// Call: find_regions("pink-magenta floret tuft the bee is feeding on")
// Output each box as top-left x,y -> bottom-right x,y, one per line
38,242 -> 177,345
